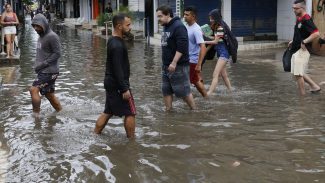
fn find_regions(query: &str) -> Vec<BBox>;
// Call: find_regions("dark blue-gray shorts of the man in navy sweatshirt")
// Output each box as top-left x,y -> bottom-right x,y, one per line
161,65 -> 191,98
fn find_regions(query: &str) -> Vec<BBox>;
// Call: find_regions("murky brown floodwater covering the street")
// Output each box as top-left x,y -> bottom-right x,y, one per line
0,19 -> 325,183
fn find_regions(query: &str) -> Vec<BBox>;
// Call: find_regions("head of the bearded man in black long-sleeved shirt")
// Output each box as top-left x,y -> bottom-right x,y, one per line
113,13 -> 131,34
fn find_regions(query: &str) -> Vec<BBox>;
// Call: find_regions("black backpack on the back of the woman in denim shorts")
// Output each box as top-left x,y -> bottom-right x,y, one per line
221,20 -> 238,63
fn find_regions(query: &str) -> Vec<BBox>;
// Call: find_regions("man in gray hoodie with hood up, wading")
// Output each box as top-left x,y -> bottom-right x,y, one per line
29,14 -> 62,116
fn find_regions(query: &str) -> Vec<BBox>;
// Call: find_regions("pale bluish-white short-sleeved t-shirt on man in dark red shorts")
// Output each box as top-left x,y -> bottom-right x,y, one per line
186,23 -> 204,64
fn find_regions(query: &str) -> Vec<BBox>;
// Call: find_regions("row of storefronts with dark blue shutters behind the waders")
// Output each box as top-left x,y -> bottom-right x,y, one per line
58,0 -> 312,40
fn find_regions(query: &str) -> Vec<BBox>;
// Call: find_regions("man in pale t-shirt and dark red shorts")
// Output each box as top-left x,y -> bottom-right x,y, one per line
184,6 -> 207,97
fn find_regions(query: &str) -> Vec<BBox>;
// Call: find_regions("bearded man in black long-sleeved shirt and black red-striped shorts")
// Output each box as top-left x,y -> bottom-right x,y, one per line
94,14 -> 136,138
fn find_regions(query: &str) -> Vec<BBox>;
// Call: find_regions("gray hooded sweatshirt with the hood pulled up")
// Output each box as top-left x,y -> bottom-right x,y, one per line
32,14 -> 61,74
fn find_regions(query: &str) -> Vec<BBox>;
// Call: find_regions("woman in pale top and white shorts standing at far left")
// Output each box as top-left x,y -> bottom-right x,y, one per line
1,4 -> 19,58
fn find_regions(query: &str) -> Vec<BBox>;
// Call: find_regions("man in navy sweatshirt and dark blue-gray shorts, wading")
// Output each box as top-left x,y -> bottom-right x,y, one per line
156,6 -> 195,111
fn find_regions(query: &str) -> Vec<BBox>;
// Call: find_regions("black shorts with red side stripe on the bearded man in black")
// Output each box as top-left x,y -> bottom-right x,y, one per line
104,91 -> 136,117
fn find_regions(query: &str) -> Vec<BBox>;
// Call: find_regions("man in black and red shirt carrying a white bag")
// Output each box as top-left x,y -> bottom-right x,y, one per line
288,0 -> 321,95
